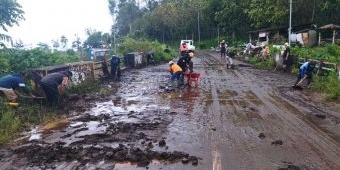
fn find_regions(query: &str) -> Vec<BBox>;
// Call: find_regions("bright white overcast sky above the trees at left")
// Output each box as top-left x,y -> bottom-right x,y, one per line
7,0 -> 113,45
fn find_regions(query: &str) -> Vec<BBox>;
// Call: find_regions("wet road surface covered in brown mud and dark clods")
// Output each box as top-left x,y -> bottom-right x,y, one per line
0,52 -> 340,170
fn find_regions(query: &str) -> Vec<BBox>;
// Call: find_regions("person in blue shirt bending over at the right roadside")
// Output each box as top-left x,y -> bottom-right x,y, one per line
293,60 -> 315,87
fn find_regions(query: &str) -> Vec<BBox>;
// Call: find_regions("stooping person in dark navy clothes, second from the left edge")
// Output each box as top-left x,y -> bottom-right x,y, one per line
40,71 -> 72,105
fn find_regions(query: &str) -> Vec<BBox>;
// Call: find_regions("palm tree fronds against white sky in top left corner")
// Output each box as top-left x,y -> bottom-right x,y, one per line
0,0 -> 25,31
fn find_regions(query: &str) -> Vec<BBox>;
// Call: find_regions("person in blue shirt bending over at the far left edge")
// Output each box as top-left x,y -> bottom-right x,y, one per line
0,72 -> 35,101
